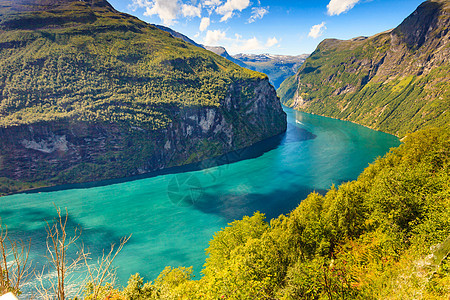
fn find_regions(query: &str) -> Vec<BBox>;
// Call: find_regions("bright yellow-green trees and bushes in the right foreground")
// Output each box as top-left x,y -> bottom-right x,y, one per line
94,127 -> 450,299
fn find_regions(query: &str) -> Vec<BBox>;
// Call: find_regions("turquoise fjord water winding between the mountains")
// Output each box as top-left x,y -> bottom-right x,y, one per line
0,108 -> 400,284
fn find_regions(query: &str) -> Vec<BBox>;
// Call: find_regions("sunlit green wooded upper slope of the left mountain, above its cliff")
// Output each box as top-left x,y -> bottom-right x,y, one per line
0,1 -> 265,129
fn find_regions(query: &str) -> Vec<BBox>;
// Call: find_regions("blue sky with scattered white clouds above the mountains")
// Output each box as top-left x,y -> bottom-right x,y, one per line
109,0 -> 423,55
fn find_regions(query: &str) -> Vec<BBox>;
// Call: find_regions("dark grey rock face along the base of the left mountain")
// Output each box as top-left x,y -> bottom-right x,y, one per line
0,79 -> 286,193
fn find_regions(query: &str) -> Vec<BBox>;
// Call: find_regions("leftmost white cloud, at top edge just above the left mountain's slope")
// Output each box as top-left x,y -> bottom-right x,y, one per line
131,0 -> 180,25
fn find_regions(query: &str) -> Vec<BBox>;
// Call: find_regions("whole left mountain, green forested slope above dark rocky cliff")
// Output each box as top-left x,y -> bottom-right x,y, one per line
0,0 -> 286,194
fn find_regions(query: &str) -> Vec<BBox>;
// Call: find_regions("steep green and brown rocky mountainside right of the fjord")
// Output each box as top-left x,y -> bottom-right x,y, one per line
278,0 -> 450,136
